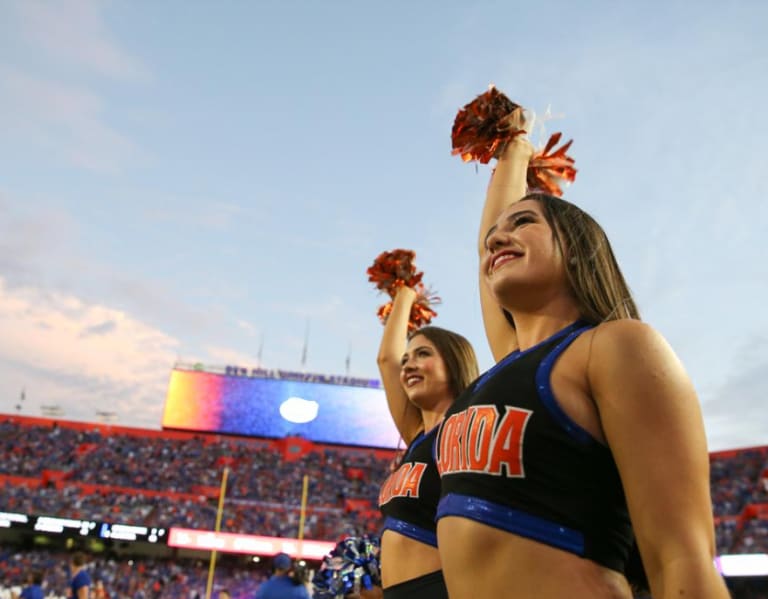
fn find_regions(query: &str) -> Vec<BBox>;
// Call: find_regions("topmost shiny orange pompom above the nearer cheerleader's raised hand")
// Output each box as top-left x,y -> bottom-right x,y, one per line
451,86 -> 525,164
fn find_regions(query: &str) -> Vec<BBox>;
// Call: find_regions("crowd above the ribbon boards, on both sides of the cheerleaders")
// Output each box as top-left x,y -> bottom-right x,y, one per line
0,420 -> 768,553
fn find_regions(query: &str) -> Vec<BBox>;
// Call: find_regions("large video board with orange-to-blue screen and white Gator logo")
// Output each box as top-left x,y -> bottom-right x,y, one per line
163,369 -> 400,449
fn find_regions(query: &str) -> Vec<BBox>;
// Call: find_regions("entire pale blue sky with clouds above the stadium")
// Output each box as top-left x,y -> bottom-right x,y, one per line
0,1 -> 768,449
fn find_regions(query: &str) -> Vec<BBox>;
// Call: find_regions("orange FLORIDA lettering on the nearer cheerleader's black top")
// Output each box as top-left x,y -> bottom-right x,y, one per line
437,405 -> 533,478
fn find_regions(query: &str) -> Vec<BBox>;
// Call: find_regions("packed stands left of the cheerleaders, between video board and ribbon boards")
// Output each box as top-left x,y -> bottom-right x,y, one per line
0,419 -> 393,540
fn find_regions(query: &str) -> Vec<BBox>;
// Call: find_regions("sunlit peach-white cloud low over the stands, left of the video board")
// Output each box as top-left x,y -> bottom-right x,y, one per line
0,278 -> 179,428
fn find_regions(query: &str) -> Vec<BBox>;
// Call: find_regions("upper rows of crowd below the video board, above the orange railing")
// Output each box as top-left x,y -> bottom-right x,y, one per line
0,421 -> 390,506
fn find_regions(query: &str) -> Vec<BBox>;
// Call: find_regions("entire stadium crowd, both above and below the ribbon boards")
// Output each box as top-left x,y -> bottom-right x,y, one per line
0,417 -> 768,599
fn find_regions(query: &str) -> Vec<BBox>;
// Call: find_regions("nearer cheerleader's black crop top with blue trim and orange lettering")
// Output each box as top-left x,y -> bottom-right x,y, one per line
436,323 -> 633,572
